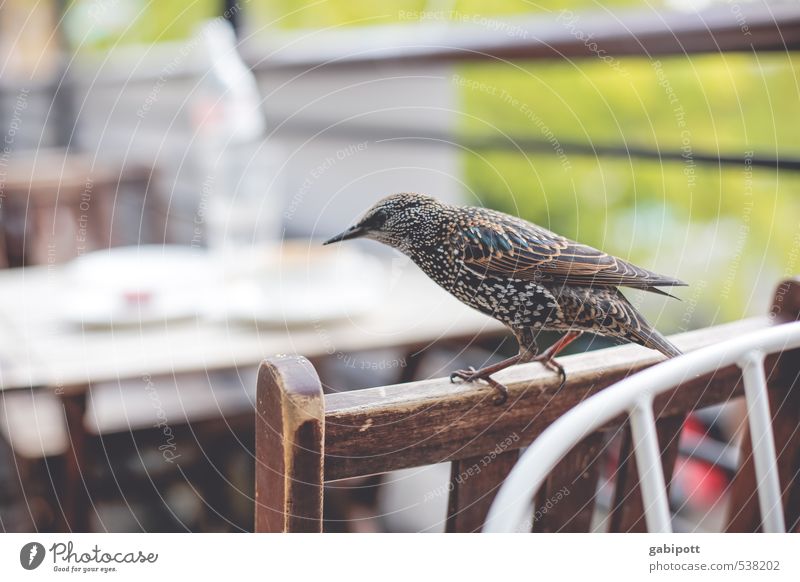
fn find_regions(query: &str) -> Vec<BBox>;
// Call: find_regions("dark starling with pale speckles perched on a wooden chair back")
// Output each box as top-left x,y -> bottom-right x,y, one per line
324,194 -> 686,404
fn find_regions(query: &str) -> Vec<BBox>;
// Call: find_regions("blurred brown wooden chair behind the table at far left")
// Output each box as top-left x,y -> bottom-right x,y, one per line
0,149 -> 166,267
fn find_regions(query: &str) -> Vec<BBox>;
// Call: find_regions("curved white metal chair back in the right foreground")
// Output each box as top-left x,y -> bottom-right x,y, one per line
483,322 -> 800,532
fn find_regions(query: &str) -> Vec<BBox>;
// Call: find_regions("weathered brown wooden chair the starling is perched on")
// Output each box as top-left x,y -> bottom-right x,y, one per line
255,279 -> 800,532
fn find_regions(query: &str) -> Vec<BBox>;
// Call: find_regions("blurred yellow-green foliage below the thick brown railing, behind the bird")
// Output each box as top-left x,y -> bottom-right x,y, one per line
457,55 -> 800,328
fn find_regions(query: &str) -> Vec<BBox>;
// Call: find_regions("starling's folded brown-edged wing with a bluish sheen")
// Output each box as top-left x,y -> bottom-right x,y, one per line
452,209 -> 685,289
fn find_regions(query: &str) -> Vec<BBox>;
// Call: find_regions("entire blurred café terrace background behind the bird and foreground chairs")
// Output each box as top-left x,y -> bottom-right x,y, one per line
0,0 -> 800,531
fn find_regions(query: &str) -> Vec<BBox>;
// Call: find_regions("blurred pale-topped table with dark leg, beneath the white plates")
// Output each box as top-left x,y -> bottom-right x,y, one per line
0,253 -> 503,531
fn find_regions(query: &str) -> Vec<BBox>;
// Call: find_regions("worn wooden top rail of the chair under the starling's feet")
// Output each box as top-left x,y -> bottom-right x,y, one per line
318,317 -> 769,480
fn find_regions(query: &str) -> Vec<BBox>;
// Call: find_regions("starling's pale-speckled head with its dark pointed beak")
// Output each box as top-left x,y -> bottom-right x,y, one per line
323,194 -> 445,250
